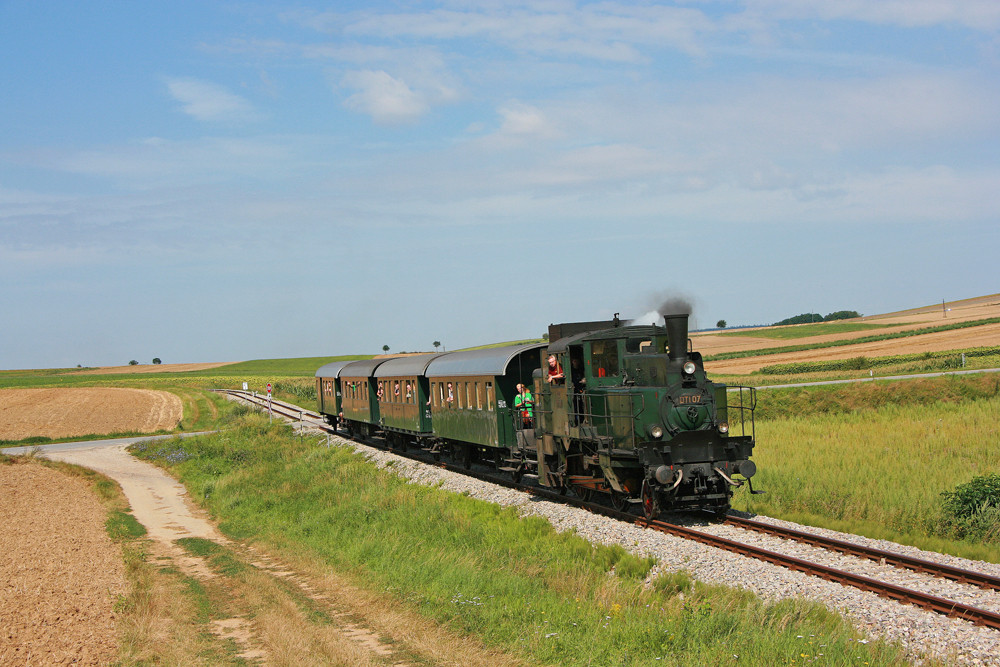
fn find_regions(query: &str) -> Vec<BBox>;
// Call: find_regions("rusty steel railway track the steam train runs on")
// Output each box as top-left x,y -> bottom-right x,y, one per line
225,390 -> 1000,630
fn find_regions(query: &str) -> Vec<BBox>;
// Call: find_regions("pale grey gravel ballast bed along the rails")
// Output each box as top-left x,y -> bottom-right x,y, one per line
330,437 -> 1000,665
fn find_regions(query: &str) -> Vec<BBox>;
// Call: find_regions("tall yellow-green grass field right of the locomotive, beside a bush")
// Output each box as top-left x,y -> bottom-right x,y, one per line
734,377 -> 1000,562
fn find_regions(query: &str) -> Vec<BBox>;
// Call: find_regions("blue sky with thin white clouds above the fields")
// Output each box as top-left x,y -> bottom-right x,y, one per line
0,0 -> 1000,368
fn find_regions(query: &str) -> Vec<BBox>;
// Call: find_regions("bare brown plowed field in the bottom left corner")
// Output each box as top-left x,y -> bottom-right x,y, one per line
0,463 -> 127,665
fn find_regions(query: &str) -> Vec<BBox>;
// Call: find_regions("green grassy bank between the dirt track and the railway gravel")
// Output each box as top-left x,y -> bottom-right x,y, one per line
136,415 -> 916,665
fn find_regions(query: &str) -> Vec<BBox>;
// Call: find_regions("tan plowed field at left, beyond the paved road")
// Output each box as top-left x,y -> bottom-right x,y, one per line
0,387 -> 184,440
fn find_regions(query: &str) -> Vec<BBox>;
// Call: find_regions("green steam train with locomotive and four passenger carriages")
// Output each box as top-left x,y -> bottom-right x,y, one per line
316,314 -> 759,518
